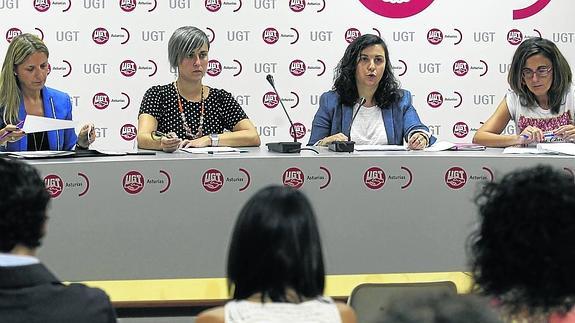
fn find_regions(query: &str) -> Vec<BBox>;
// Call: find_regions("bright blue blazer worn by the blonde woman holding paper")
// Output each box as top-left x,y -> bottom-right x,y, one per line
1,86 -> 78,151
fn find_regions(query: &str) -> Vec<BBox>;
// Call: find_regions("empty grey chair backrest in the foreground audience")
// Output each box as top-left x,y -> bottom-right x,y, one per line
348,281 -> 457,323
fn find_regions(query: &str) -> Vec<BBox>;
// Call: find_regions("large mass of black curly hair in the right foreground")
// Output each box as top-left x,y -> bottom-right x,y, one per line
469,165 -> 575,315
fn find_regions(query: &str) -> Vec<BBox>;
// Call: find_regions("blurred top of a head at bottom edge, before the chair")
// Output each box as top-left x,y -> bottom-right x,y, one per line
380,292 -> 501,323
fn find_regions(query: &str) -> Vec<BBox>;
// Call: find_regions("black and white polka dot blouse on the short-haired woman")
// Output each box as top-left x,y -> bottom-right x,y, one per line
139,83 -> 248,139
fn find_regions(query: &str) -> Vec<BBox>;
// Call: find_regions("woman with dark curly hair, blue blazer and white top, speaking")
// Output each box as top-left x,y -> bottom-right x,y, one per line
308,34 -> 435,149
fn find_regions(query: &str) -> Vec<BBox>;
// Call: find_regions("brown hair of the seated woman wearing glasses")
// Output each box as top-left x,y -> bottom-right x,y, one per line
507,37 -> 573,113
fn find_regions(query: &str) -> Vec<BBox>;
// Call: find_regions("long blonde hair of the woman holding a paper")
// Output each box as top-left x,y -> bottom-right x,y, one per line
0,34 -> 50,124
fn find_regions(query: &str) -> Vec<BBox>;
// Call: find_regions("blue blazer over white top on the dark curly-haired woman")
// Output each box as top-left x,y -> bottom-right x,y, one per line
308,90 -> 436,145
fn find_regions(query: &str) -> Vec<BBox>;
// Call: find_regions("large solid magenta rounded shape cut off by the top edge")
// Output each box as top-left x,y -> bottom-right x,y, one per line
359,0 -> 433,18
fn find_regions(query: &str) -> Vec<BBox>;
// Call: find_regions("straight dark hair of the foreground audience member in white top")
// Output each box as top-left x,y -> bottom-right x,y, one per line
227,186 -> 325,302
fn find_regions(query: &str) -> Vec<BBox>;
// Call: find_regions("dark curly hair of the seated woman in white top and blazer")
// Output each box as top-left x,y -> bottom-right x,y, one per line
333,34 -> 403,109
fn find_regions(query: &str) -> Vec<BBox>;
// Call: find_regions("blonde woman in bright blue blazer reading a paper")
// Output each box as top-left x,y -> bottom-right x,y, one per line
0,34 -> 95,151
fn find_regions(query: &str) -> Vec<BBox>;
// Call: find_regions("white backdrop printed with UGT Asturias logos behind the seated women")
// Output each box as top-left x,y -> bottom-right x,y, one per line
0,0 -> 575,149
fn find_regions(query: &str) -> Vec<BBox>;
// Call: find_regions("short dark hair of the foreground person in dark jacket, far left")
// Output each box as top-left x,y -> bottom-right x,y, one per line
0,158 -> 50,253
